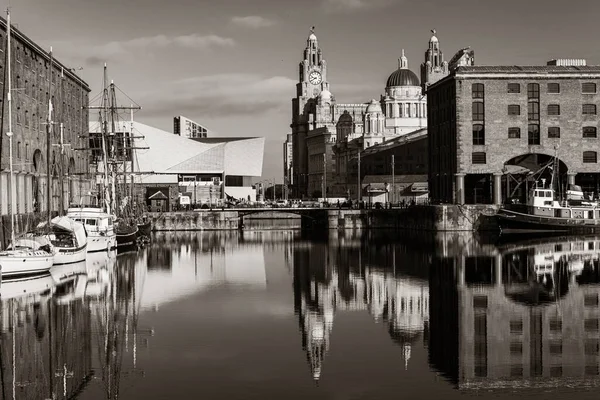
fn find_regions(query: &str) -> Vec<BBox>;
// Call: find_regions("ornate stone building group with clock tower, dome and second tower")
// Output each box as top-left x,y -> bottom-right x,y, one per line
291,32 -> 448,198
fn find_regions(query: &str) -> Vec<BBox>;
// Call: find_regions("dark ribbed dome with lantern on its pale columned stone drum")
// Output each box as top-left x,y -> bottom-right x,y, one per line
382,50 -> 427,136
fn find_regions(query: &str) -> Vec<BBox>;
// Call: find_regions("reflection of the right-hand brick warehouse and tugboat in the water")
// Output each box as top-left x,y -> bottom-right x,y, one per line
429,234 -> 600,390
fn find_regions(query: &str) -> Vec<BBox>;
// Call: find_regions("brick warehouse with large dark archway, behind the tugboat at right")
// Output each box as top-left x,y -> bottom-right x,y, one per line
427,60 -> 600,204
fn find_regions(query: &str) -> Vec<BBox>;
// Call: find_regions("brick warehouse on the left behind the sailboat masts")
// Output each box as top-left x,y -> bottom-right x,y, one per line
0,18 -> 90,230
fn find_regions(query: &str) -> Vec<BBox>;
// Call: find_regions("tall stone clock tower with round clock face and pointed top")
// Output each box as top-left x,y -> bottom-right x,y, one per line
290,27 -> 333,198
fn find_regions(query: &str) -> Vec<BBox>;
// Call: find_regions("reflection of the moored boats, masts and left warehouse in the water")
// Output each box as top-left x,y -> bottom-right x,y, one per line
0,248 -> 148,400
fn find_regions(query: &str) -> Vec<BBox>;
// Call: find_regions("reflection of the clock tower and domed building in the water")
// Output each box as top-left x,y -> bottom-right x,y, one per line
293,230 -> 429,382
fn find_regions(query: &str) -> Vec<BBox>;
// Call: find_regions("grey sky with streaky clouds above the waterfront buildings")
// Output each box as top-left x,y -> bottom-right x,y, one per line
8,0 -> 600,182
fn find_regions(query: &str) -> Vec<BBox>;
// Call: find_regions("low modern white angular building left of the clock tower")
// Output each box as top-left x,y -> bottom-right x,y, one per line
121,122 -> 265,210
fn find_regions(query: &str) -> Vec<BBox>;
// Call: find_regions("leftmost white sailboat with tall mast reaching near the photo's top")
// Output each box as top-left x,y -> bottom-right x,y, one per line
0,10 -> 54,277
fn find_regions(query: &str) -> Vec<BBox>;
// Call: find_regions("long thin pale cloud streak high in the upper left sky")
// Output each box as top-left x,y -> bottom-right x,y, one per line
44,33 -> 236,65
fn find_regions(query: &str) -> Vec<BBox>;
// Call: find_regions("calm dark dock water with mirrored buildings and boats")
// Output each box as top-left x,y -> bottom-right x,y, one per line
0,231 -> 600,399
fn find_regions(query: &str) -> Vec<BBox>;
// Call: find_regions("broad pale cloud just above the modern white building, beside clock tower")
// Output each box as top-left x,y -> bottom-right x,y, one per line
138,73 -> 296,118
